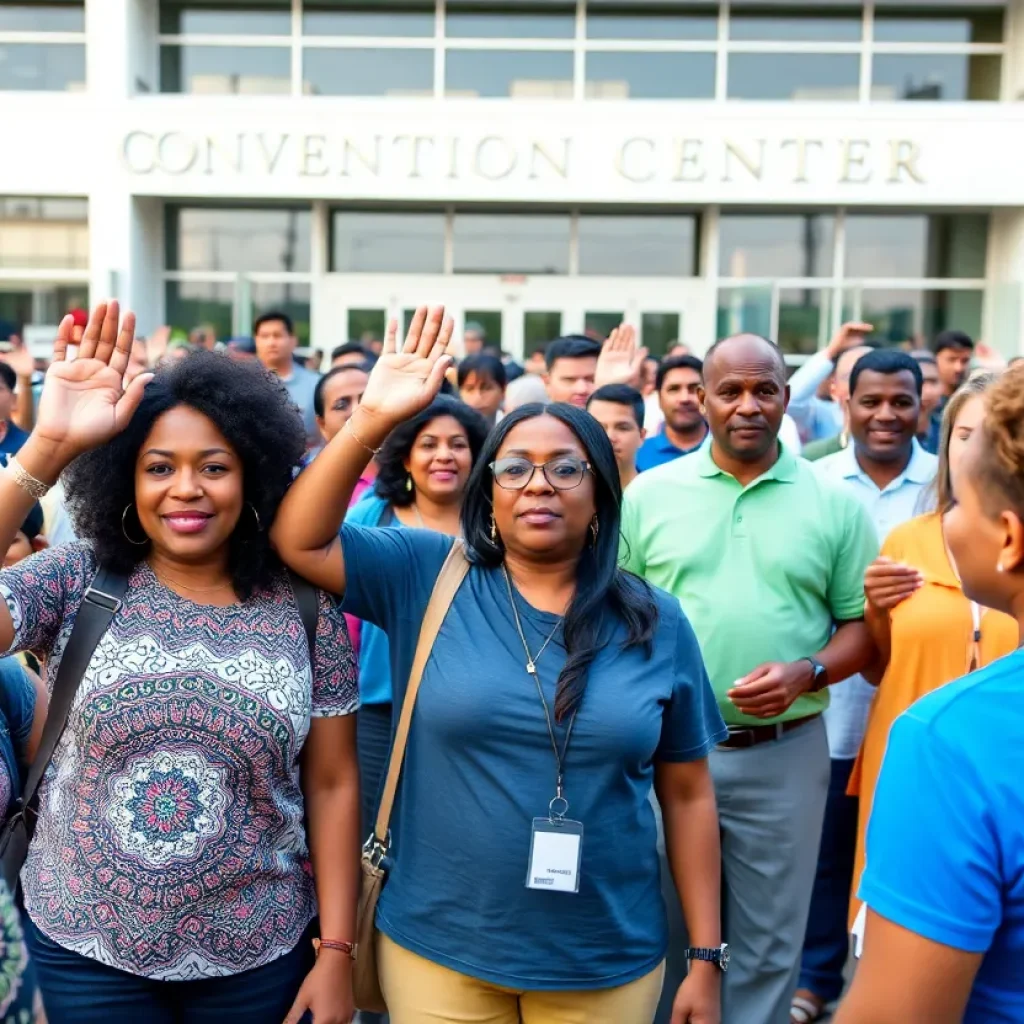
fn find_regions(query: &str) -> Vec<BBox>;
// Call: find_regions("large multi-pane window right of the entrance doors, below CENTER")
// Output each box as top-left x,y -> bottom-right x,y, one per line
718,211 -> 988,355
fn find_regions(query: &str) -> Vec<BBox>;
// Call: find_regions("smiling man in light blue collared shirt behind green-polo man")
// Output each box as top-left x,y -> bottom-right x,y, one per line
794,349 -> 938,1014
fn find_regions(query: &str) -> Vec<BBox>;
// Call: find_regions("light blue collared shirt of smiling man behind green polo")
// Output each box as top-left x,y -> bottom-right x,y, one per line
812,440 -> 939,760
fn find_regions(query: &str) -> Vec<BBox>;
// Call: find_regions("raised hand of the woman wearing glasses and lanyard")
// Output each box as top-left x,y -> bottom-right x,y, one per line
359,306 -> 454,424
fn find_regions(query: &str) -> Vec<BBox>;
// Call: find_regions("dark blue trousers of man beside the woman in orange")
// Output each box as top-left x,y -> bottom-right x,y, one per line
800,759 -> 858,1002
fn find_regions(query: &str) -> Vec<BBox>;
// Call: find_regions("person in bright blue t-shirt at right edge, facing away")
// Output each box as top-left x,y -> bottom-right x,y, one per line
837,367 -> 1024,1024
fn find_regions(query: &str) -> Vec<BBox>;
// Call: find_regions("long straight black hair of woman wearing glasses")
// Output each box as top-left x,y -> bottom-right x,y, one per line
462,402 -> 657,721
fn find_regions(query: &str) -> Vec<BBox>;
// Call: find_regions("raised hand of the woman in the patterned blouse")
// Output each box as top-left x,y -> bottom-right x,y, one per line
35,301 -> 153,461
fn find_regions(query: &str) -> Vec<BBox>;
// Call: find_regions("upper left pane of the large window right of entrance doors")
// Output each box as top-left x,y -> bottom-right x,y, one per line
719,213 -> 836,279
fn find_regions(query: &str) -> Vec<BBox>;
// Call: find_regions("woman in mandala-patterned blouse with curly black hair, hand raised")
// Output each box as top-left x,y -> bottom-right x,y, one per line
0,302 -> 358,1024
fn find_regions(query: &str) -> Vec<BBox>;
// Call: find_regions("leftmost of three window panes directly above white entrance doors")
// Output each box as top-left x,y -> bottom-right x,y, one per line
331,210 -> 444,273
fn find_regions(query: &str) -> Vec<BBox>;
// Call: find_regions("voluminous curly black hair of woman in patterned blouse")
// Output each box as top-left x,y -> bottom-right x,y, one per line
65,350 -> 305,600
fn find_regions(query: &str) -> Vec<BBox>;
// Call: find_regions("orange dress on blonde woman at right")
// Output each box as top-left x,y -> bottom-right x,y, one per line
847,513 -> 1018,923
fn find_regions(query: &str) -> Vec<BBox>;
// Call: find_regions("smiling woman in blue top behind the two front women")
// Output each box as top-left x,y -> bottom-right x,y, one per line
347,395 -> 487,876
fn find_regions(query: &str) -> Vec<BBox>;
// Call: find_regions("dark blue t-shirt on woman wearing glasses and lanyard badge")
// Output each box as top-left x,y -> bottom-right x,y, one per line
341,523 -> 725,990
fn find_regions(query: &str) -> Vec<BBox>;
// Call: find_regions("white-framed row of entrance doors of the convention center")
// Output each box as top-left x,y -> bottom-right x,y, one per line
313,274 -> 714,360
